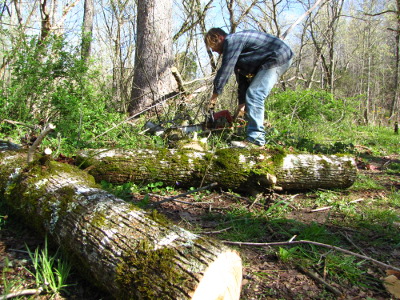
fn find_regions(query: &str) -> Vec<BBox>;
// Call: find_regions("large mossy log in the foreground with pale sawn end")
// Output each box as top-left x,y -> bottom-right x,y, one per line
0,150 -> 242,299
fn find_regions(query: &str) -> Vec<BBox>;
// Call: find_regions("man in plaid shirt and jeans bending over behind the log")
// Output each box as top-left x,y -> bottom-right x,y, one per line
205,28 -> 293,148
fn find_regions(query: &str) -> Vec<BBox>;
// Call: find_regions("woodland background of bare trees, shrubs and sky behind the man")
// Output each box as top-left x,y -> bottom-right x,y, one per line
0,0 -> 400,146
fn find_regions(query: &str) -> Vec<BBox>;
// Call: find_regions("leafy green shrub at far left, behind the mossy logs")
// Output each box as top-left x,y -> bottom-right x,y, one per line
0,37 -> 133,150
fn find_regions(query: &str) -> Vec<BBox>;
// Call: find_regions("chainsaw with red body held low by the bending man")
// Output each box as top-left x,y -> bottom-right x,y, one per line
144,110 -> 234,136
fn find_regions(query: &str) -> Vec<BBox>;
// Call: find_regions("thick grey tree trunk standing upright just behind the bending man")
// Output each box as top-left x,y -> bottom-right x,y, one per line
129,0 -> 176,115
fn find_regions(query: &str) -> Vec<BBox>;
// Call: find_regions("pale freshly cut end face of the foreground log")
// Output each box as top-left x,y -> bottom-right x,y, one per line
192,250 -> 242,300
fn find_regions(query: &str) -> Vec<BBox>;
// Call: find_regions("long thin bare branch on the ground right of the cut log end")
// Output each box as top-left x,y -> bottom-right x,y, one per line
223,240 -> 400,272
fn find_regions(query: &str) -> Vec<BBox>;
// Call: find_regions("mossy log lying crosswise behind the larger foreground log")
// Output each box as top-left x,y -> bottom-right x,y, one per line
77,148 -> 357,192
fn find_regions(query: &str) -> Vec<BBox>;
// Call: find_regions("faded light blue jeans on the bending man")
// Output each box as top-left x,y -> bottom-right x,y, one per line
246,60 -> 292,146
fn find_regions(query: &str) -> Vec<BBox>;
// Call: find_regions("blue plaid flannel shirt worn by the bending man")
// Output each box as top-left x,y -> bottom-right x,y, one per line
214,30 -> 293,94
